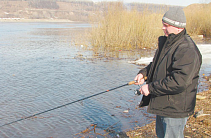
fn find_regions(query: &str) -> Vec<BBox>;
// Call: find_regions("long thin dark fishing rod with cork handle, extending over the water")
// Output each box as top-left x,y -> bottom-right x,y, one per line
0,81 -> 136,127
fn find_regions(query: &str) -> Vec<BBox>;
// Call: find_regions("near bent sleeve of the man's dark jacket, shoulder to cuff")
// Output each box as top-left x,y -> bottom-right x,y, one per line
149,44 -> 201,96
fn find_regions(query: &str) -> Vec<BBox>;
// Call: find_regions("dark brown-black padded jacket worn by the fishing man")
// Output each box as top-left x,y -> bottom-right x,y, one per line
139,29 -> 202,118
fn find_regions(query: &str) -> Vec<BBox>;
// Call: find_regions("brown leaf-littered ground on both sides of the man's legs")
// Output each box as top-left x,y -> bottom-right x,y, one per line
127,74 -> 211,138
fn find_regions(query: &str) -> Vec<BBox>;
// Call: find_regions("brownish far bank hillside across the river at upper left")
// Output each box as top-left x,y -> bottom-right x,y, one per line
0,0 -> 100,21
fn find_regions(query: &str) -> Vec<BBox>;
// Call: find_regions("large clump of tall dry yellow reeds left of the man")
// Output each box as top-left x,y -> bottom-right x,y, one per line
90,2 -> 162,51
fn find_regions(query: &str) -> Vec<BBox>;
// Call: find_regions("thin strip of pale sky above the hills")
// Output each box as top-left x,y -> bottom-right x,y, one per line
93,0 -> 211,6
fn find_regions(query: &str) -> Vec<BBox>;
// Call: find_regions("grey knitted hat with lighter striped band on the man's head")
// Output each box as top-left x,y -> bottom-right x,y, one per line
162,7 -> 186,28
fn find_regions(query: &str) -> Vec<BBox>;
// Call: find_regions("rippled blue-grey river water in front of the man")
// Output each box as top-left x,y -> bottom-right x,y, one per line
0,22 -> 211,138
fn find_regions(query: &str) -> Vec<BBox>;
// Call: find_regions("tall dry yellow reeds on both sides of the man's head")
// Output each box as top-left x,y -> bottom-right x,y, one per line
90,2 -> 211,52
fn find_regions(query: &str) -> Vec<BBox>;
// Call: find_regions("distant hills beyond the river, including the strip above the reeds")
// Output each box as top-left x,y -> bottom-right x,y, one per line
0,0 -> 174,21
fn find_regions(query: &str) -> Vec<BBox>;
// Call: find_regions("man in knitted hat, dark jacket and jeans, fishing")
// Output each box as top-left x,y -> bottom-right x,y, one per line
135,7 -> 202,138
